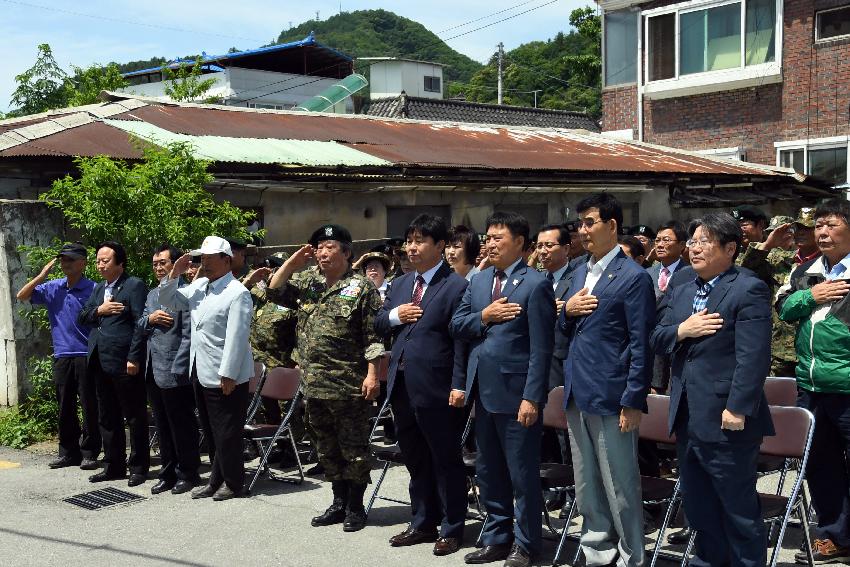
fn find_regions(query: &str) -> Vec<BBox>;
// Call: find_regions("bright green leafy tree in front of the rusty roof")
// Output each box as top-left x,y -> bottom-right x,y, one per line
42,144 -> 254,281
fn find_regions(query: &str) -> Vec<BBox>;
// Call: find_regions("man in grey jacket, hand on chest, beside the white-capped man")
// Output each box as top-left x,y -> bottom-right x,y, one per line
138,244 -> 201,494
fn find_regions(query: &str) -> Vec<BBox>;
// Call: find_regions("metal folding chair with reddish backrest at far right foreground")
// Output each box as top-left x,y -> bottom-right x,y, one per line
682,406 -> 815,567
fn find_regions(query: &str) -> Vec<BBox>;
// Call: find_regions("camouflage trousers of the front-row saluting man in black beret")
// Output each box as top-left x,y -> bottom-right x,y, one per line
307,398 -> 371,484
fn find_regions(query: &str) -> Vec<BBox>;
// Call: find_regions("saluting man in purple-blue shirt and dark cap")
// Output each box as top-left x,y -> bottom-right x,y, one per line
17,243 -> 101,470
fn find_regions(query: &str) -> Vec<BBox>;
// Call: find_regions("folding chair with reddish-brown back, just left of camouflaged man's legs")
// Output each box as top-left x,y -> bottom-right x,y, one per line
244,368 -> 304,492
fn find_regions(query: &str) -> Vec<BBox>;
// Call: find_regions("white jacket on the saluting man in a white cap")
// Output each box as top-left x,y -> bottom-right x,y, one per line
159,272 -> 254,388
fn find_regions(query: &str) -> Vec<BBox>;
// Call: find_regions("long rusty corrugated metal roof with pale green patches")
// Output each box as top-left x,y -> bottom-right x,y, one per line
0,93 -> 820,183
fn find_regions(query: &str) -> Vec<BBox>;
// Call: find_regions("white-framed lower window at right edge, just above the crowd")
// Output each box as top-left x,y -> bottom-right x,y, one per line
775,136 -> 850,185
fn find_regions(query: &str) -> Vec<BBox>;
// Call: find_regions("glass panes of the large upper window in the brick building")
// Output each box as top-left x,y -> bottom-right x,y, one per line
645,0 -> 779,88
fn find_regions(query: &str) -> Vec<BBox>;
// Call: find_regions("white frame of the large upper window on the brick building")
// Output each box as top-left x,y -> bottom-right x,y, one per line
639,0 -> 783,99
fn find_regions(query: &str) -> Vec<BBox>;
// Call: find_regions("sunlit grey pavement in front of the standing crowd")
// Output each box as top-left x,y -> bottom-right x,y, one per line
0,447 -> 800,567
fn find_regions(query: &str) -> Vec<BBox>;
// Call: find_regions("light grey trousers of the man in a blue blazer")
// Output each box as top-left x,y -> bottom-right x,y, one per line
567,400 -> 644,567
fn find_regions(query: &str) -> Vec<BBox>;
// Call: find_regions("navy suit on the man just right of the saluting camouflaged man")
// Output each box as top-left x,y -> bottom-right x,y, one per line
375,262 -> 467,538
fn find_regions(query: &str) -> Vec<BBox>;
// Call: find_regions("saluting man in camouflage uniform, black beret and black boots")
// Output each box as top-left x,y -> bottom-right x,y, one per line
269,224 -> 384,532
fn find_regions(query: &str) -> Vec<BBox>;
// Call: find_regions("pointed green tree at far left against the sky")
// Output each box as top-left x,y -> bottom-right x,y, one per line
12,43 -> 68,116
